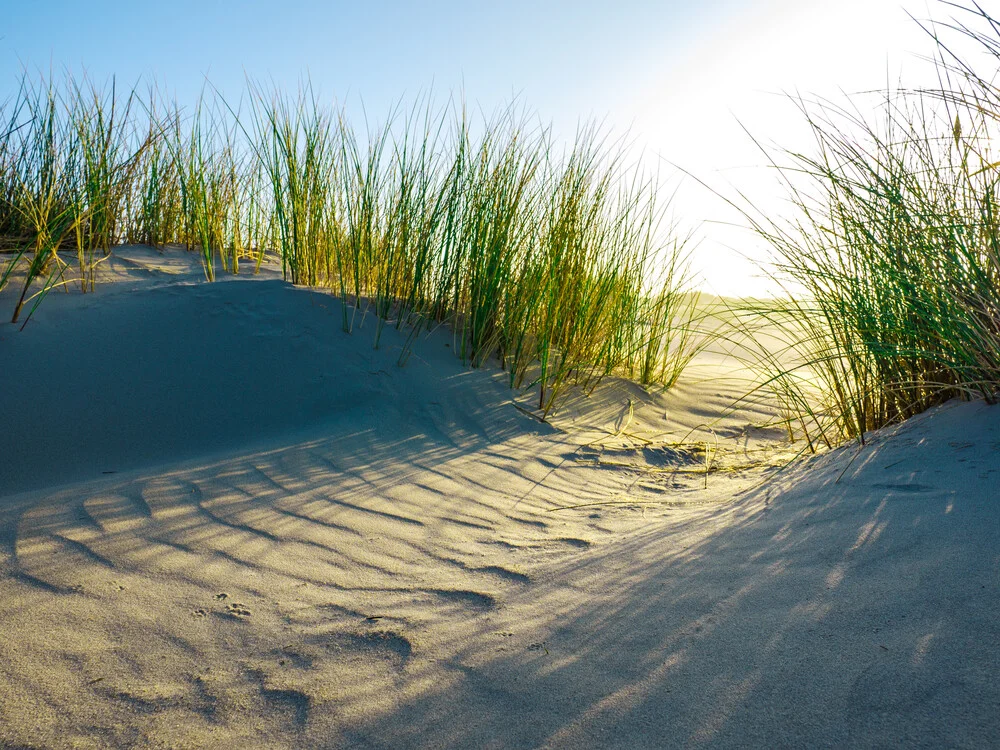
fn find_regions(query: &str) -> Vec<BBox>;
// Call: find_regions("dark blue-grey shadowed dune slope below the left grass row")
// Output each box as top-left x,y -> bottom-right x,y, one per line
0,278 -> 546,497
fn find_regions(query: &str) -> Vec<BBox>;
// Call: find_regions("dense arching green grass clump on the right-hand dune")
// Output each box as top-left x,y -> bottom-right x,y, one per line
736,1 -> 1000,444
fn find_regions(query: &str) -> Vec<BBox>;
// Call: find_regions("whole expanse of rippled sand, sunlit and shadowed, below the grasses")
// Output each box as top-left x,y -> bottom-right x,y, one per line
0,248 -> 1000,748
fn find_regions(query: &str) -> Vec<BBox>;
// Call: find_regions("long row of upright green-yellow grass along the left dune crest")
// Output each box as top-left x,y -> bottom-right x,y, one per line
0,76 -> 698,414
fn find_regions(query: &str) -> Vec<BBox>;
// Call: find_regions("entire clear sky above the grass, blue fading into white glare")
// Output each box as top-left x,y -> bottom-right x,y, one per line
0,0 -> 950,293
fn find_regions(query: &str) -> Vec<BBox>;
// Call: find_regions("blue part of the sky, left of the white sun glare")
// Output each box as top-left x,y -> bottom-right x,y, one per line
0,0 -> 736,126
